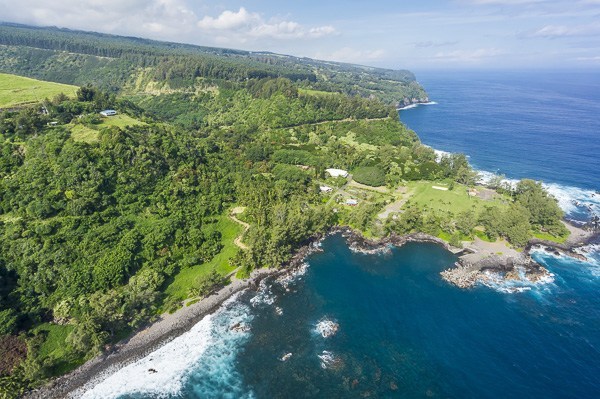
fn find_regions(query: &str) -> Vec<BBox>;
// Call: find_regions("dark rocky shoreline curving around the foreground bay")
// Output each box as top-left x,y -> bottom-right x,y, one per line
24,226 -> 599,398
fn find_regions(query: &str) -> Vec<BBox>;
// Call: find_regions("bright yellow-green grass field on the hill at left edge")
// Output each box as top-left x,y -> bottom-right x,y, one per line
0,73 -> 78,108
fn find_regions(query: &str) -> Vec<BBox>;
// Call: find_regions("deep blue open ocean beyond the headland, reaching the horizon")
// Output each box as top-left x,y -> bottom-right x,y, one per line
400,71 -> 600,221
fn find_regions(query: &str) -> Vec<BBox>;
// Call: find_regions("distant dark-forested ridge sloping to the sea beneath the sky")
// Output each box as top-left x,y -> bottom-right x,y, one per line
0,23 -> 427,105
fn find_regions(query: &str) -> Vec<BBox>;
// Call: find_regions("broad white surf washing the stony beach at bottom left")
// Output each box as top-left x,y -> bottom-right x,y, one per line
81,294 -> 252,399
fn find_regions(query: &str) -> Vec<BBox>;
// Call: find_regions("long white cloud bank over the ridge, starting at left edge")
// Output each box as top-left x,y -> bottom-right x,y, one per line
0,0 -> 337,48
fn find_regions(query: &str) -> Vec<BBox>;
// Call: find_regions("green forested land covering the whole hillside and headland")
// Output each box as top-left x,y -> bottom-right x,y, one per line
0,25 -> 565,397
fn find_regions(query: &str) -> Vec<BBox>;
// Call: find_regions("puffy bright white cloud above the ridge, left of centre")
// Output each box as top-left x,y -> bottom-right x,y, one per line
197,7 -> 337,40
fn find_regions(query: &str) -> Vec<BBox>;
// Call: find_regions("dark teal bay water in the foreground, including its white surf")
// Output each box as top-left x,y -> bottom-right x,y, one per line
88,235 -> 600,398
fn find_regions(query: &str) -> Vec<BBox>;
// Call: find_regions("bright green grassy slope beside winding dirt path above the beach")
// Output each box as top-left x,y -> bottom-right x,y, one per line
165,215 -> 243,301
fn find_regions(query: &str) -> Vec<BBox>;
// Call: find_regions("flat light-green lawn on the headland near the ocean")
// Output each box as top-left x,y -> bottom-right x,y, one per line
407,181 -> 505,214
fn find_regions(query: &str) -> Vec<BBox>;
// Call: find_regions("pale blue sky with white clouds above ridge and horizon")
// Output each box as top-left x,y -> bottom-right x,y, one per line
0,0 -> 600,70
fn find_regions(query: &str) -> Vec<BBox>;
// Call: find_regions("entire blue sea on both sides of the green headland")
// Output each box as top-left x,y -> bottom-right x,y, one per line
84,73 -> 600,399
